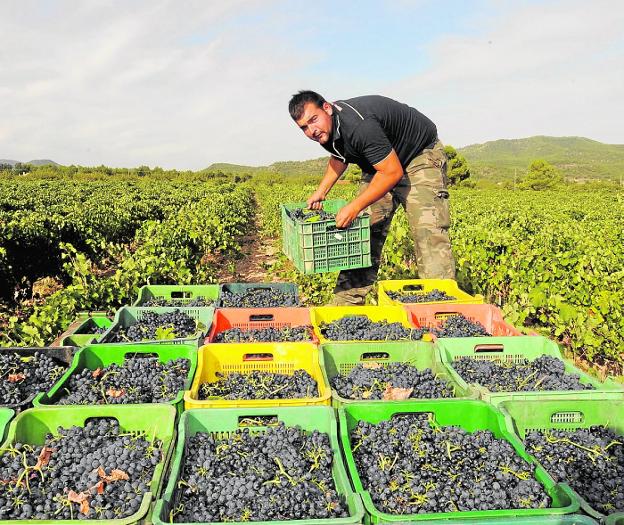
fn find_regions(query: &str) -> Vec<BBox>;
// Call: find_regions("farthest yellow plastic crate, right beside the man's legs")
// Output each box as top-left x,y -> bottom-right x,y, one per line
377,279 -> 485,306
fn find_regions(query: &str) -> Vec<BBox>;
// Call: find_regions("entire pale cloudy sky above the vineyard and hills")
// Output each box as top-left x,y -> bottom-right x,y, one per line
0,0 -> 624,169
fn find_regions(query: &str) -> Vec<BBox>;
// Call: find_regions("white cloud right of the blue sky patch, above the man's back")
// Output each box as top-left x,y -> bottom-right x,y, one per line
387,1 -> 624,146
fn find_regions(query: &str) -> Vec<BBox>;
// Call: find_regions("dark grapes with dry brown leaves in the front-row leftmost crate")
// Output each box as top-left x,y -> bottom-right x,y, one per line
0,419 -> 162,520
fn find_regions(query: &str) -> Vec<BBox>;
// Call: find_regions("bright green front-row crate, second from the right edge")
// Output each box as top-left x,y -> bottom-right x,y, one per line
338,399 -> 580,524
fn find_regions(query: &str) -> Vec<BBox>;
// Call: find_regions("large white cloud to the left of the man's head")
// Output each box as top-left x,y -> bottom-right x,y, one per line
0,1 -> 321,169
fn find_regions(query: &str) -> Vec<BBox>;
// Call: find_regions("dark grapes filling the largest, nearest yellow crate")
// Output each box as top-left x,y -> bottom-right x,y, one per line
199,370 -> 319,400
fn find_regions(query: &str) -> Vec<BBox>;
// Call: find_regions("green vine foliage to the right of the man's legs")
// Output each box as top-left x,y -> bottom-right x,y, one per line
451,190 -> 624,367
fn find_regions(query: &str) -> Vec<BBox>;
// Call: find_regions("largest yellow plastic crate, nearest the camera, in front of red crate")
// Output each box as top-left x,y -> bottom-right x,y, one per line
184,343 -> 331,410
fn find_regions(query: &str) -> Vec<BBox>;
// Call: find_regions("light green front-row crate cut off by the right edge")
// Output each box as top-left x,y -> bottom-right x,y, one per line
499,399 -> 624,519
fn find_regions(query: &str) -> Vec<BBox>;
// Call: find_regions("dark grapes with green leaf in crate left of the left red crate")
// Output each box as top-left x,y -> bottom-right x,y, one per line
109,310 -> 197,343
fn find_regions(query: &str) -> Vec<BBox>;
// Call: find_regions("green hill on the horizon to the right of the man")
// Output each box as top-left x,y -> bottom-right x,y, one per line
458,136 -> 624,180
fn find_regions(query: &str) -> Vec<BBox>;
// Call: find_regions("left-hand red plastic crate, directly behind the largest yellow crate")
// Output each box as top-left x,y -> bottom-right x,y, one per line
204,307 -> 318,344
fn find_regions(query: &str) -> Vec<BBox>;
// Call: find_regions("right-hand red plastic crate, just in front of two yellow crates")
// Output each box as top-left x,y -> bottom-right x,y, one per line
404,304 -> 524,339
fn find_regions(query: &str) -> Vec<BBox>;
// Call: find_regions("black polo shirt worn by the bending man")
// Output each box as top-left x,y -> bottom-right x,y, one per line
323,95 -> 438,180
